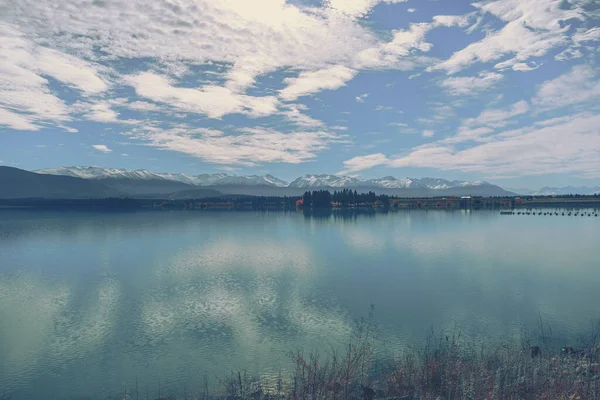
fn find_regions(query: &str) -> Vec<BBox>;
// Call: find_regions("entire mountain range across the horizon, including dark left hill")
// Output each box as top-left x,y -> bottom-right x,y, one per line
0,166 -> 600,199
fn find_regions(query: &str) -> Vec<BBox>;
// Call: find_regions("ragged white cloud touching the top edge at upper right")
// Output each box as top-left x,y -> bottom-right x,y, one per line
430,0 -> 583,74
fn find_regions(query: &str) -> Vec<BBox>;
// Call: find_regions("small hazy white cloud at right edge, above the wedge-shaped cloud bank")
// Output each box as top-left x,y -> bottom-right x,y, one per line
533,65 -> 600,110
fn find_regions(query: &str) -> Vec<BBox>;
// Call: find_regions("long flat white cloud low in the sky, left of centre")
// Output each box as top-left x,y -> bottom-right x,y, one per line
128,125 -> 345,166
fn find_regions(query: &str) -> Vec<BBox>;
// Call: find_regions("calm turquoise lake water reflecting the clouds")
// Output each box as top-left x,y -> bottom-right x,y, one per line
0,211 -> 600,399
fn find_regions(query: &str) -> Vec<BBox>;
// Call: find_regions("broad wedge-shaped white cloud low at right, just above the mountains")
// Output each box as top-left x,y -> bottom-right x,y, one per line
389,114 -> 600,178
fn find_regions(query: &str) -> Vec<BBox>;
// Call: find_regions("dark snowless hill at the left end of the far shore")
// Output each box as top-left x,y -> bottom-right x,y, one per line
0,166 -> 121,199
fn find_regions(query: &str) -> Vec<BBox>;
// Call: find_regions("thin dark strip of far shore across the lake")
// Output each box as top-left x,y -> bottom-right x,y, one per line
0,194 -> 600,213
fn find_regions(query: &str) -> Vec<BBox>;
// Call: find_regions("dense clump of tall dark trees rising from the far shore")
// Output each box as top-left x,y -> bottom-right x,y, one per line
302,189 -> 390,208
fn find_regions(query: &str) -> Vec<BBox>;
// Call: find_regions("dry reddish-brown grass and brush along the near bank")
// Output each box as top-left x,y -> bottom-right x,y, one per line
88,312 -> 600,400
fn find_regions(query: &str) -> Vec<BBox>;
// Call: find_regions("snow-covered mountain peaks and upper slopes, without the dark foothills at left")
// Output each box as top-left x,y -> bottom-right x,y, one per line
35,166 -> 508,195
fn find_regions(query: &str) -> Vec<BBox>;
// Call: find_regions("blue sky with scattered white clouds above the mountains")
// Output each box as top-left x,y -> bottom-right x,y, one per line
0,0 -> 600,189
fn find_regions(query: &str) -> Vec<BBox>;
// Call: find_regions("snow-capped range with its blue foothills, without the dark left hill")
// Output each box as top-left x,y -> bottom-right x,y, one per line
35,166 -> 514,197
